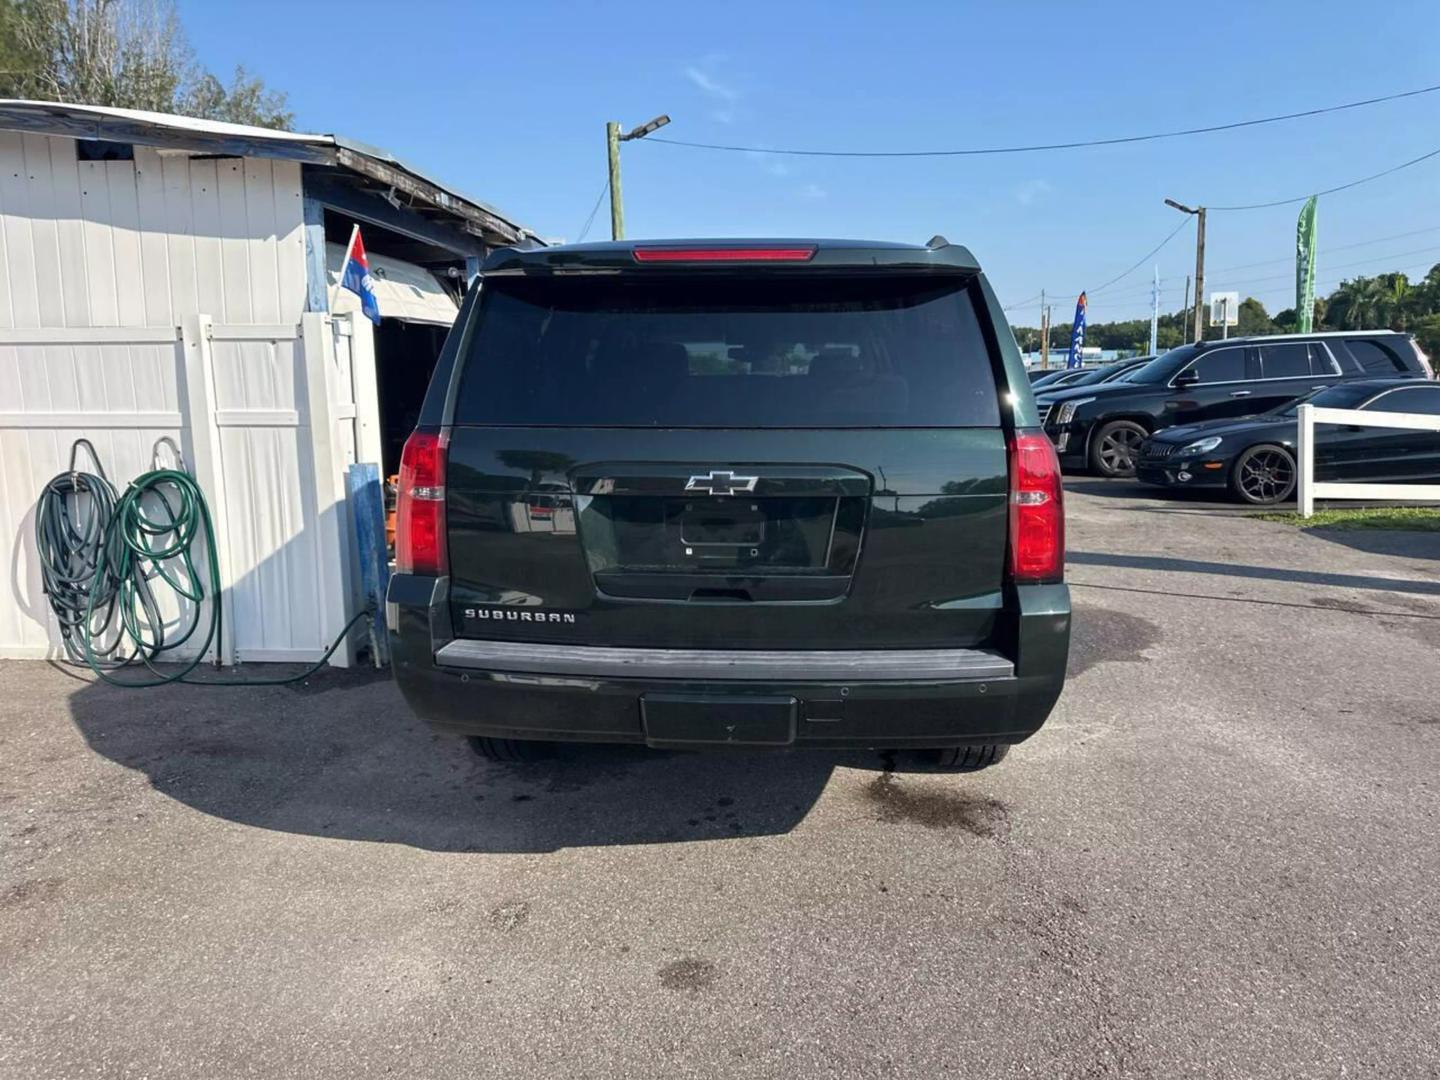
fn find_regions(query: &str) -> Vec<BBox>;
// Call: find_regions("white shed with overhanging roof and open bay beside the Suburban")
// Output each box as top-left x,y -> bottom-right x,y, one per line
0,101 -> 534,673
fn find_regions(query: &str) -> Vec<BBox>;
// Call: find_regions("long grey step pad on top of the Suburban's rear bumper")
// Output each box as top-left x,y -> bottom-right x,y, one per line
435,638 -> 1015,683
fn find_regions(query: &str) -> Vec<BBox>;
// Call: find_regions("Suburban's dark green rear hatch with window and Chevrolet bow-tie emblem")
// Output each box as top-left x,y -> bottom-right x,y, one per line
446,266 -> 1008,648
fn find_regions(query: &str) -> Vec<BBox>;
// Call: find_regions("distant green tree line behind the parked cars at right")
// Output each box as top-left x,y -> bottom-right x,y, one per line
1014,264 -> 1440,357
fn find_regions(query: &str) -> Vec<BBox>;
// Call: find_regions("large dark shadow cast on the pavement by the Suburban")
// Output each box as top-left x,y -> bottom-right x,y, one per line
69,670 -> 933,852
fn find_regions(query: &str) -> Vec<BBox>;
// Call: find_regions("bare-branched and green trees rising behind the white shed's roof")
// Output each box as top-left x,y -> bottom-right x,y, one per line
0,0 -> 295,128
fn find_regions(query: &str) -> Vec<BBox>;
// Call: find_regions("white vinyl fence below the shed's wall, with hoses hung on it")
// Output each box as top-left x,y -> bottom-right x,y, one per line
0,314 -> 360,664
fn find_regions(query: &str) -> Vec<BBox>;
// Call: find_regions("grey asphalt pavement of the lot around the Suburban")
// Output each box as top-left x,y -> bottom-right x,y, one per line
0,481 -> 1440,1080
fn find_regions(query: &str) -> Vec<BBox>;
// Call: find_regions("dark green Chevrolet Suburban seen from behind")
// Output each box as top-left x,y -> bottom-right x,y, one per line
386,238 -> 1070,768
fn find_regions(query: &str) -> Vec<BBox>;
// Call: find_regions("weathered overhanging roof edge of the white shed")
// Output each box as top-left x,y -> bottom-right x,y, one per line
0,98 -> 540,240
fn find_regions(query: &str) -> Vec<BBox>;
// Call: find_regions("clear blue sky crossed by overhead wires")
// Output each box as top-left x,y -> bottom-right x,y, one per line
180,0 -> 1440,324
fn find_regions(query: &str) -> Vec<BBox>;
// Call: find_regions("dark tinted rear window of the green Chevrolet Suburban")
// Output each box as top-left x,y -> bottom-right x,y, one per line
455,275 -> 999,428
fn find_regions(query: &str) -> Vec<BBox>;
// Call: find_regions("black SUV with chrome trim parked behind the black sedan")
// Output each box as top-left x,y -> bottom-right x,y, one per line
1040,330 -> 1431,477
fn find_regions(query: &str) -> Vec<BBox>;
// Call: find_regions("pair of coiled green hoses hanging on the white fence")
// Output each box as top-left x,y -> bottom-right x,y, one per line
36,441 -> 373,687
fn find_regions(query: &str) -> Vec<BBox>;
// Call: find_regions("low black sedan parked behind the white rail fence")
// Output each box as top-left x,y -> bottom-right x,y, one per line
1136,377 -> 1440,504
